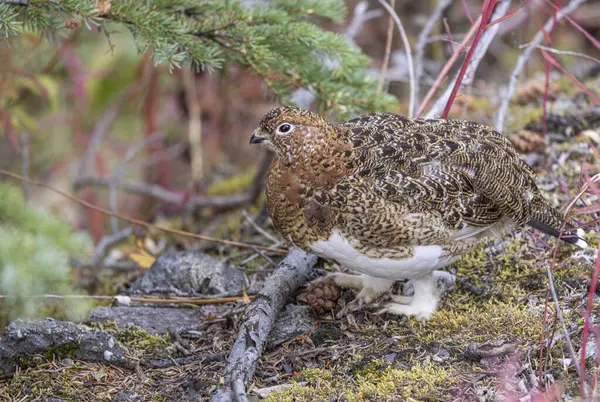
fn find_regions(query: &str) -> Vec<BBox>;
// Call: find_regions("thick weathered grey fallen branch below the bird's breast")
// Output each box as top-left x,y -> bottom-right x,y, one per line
211,249 -> 317,402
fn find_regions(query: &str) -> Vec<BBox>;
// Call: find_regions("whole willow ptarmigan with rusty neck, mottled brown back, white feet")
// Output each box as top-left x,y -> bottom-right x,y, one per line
250,107 -> 587,319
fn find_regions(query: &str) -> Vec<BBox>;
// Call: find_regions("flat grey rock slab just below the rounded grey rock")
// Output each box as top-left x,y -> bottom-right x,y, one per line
88,307 -> 204,335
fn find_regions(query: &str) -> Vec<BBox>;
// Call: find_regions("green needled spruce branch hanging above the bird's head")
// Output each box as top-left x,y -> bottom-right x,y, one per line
0,0 -> 396,117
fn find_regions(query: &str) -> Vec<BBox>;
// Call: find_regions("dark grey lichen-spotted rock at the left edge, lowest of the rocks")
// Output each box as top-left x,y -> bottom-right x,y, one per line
0,318 -> 127,374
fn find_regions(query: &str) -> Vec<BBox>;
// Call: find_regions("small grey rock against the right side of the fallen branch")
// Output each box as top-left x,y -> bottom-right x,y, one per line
267,304 -> 317,347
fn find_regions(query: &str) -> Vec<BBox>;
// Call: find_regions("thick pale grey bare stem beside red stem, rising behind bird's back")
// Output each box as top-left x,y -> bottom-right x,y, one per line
425,0 -> 510,119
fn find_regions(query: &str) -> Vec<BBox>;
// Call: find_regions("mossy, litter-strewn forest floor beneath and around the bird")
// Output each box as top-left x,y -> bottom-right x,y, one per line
0,73 -> 600,401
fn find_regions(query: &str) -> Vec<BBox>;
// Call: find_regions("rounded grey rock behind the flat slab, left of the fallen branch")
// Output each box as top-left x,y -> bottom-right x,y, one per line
132,251 -> 247,295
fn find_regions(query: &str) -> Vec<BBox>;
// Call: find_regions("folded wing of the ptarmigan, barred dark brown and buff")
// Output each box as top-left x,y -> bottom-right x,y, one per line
340,113 -> 539,232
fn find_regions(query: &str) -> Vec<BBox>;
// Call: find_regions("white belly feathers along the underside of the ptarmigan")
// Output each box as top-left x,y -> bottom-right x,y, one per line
310,231 -> 452,280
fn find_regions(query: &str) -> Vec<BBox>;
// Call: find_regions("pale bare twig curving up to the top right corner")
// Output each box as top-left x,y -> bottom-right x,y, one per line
495,0 -> 586,132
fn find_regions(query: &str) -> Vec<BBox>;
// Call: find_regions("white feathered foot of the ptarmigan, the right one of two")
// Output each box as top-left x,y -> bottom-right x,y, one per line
378,271 -> 456,321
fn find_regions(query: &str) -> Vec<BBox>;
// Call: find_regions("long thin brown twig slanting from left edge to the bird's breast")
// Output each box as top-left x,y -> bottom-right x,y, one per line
0,169 -> 285,254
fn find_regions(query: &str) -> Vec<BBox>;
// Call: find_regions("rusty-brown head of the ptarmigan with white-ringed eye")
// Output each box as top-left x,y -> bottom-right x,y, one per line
250,107 -> 334,163
